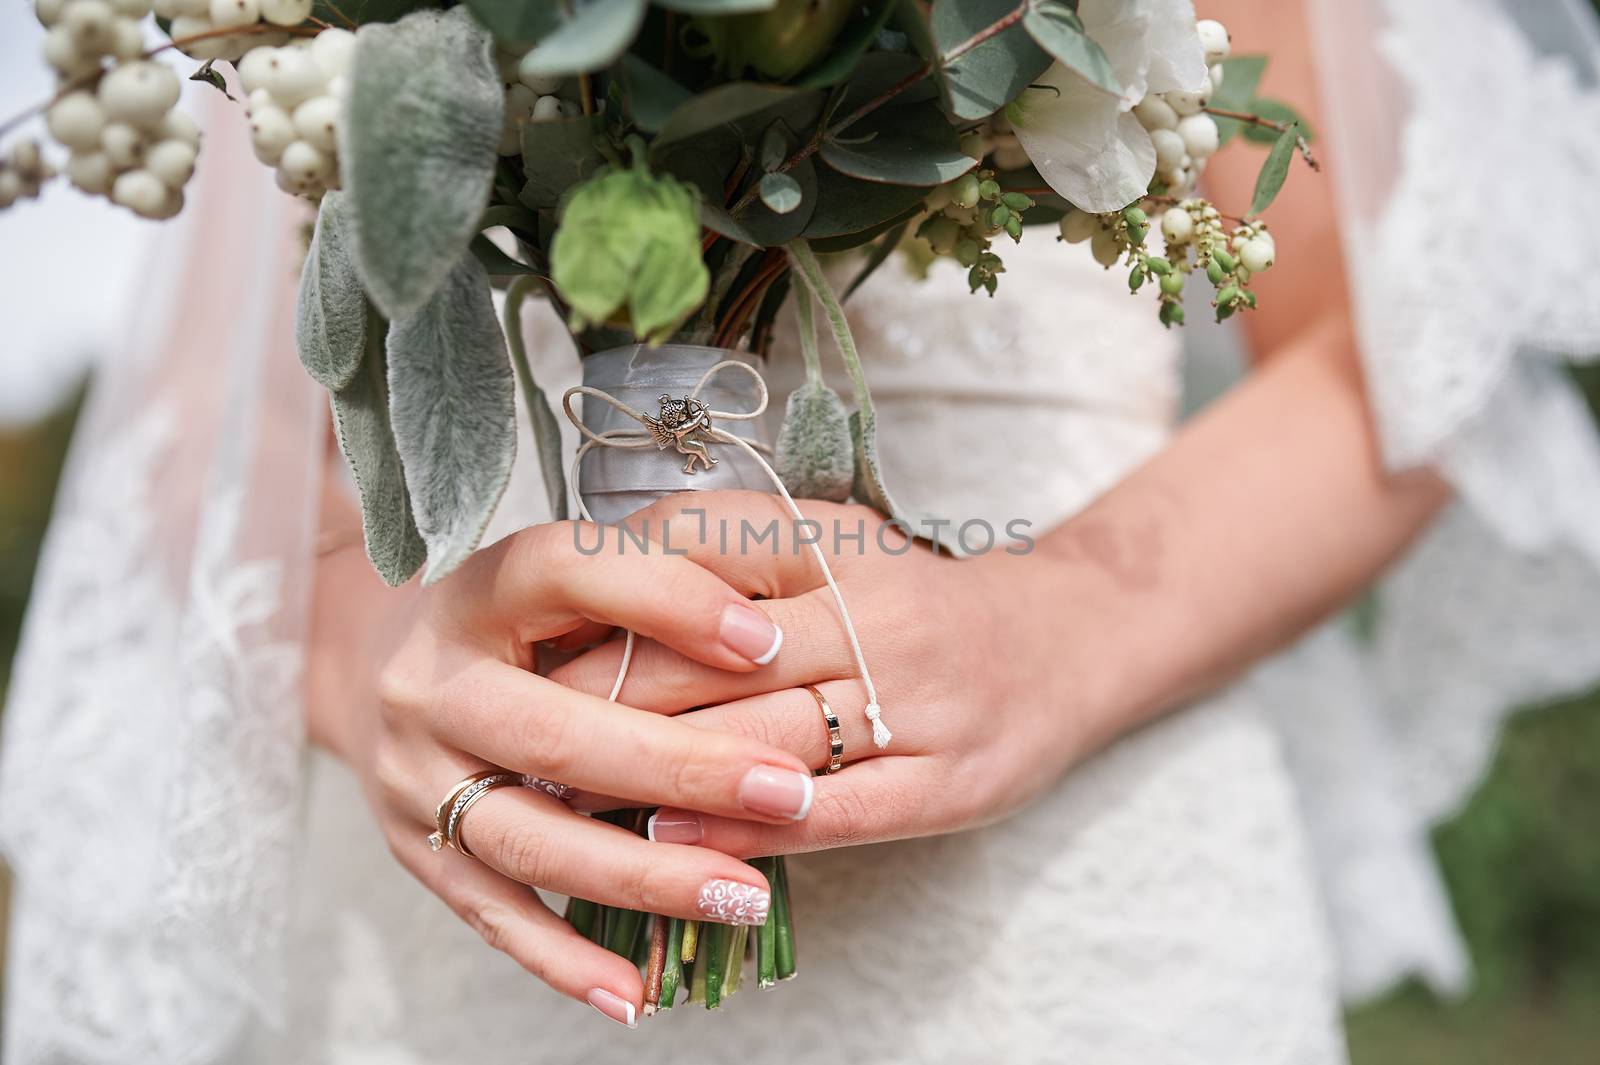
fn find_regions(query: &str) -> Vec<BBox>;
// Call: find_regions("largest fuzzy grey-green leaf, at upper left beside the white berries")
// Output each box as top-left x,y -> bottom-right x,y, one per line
339,8 -> 506,318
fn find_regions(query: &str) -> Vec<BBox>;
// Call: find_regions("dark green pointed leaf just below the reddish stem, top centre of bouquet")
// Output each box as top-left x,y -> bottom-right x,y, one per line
819,102 -> 978,185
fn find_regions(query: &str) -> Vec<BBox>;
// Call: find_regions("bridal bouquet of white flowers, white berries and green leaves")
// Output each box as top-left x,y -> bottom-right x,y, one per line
0,0 -> 1315,1007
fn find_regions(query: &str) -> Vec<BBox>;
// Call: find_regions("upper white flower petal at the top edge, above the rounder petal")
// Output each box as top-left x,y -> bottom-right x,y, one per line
1078,0 -> 1206,110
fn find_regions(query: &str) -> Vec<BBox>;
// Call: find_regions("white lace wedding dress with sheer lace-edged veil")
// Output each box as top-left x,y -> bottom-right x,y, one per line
0,0 -> 1600,1065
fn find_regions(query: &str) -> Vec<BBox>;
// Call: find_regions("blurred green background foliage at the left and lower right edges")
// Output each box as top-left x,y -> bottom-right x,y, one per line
0,373 -> 1600,1065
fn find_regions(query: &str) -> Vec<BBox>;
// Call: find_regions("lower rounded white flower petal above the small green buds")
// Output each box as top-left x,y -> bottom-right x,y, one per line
1011,62 -> 1152,213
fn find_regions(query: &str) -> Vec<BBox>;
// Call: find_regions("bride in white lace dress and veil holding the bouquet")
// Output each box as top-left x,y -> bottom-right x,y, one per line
3,0 -> 1600,1065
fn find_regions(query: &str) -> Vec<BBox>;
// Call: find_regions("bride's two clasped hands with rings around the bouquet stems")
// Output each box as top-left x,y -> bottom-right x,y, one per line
341,493 -> 1078,1022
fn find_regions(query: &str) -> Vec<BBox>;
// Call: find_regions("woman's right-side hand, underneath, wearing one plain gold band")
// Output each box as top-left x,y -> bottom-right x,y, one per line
550,493 -> 1085,856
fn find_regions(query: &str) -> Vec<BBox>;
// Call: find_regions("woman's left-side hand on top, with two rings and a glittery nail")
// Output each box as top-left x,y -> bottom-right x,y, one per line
310,511 -> 811,1023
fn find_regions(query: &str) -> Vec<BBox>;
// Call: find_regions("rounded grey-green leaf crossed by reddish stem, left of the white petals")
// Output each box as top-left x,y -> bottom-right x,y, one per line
931,0 -> 1051,120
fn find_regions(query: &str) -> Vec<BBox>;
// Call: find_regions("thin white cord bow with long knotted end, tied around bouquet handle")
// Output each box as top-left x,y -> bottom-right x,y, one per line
562,360 -> 893,750
